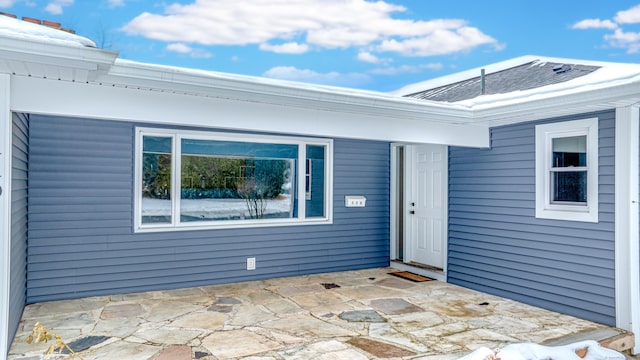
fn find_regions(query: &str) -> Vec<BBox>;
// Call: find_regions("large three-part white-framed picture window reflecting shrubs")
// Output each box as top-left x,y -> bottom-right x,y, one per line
134,127 -> 333,232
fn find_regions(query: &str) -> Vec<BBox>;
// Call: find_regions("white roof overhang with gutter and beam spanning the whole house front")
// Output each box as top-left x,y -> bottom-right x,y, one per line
0,35 -> 640,147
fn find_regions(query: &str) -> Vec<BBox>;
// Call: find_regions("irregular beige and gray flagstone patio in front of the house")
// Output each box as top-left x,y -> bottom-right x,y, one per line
8,268 -> 632,360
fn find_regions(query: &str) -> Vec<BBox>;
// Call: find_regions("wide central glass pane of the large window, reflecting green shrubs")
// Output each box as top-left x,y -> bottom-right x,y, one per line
180,139 -> 298,222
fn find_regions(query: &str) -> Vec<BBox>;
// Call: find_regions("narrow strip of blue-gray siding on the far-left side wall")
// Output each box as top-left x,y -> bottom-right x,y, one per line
8,114 -> 29,341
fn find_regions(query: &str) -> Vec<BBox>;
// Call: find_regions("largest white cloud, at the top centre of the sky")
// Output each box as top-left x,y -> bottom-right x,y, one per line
123,0 -> 499,56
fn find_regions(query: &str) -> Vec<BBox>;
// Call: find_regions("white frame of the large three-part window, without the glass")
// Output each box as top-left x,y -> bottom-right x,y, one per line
133,127 -> 333,232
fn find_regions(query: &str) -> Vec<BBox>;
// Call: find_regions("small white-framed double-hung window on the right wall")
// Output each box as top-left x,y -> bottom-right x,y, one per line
536,118 -> 598,222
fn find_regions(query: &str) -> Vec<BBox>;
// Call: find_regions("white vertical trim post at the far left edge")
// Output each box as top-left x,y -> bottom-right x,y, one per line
0,74 -> 12,359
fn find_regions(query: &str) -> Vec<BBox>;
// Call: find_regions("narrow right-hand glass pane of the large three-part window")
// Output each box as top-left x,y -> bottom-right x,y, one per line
305,145 -> 326,218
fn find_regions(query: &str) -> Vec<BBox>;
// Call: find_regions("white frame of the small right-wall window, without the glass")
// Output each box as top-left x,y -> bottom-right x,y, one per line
535,118 -> 599,223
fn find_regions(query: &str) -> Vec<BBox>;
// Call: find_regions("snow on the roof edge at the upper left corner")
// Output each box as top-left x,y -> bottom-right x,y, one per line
0,16 -> 96,47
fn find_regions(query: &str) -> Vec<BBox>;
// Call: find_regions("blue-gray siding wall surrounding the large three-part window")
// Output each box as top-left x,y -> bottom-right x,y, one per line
27,115 -> 389,303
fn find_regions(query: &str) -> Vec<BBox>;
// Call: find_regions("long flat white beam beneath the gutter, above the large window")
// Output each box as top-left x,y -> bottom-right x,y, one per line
11,76 -> 489,147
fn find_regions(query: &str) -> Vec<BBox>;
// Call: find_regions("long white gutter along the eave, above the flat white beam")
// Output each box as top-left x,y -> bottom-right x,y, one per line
105,60 -> 472,124
